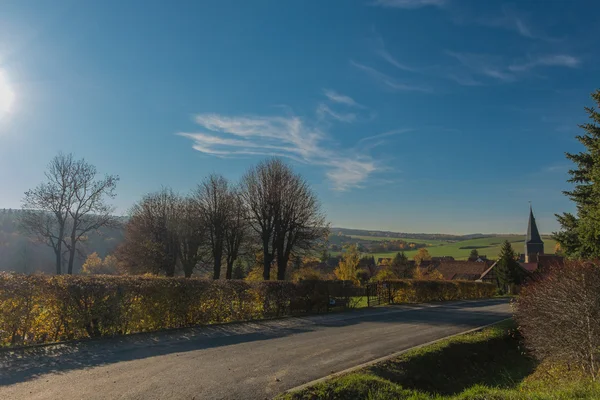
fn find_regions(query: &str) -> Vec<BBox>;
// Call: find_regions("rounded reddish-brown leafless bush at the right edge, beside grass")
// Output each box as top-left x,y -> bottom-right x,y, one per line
515,261 -> 600,378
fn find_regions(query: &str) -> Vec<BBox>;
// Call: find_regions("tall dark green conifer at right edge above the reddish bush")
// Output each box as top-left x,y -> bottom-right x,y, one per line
554,90 -> 600,258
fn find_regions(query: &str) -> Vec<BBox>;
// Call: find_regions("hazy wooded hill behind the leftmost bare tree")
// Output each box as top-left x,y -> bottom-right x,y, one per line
0,209 -> 123,273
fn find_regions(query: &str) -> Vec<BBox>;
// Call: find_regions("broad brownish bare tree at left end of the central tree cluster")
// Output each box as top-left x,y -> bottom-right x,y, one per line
116,188 -> 181,276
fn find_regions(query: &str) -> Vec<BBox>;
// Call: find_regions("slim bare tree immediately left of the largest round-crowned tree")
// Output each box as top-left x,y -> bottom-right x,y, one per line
225,190 -> 248,279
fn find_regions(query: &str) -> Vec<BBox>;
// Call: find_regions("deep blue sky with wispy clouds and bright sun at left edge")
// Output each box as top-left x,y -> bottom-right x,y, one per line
0,0 -> 600,233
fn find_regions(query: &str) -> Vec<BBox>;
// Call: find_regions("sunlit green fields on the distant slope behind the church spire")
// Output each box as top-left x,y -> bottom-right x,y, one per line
355,235 -> 556,260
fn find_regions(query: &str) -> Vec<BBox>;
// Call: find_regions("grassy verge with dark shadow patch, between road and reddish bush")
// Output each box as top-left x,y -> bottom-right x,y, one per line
279,321 -> 600,400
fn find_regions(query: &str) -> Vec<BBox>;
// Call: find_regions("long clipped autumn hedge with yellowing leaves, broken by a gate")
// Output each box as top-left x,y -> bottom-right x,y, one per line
0,273 -> 494,346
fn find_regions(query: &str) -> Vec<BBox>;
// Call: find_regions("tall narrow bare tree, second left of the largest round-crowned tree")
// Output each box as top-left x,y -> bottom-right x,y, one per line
194,174 -> 231,279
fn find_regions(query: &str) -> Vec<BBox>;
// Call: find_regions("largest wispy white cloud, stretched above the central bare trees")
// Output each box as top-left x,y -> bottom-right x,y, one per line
178,114 -> 381,190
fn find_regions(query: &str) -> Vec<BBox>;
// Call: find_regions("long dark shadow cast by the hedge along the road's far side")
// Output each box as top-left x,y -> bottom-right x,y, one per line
0,299 -> 510,386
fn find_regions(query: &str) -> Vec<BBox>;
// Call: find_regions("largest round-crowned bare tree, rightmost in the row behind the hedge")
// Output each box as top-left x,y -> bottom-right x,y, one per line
242,158 -> 329,280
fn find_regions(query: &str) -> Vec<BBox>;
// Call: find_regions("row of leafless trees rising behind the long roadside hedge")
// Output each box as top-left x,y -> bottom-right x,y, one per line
20,154 -> 329,280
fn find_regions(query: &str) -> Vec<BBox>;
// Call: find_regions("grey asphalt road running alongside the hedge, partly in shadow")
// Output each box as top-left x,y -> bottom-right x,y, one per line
0,299 -> 510,400
